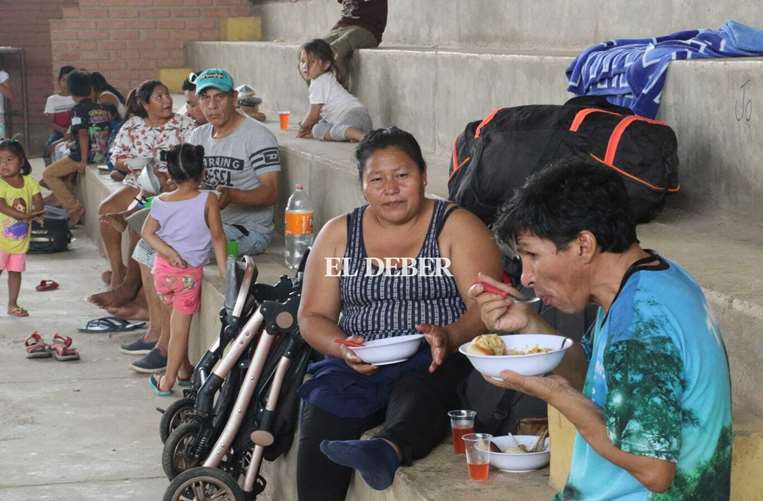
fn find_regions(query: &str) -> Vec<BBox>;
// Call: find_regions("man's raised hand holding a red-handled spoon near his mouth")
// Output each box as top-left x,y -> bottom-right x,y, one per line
469,273 -> 533,332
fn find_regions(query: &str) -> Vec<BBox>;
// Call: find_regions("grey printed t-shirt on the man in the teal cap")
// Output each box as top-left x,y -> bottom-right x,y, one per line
188,117 -> 281,234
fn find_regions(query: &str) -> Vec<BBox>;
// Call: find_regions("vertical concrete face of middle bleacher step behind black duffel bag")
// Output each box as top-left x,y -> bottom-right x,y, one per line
186,42 -> 763,223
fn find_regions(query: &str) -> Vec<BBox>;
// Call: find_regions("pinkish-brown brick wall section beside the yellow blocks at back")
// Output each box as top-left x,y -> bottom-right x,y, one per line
50,0 -> 251,99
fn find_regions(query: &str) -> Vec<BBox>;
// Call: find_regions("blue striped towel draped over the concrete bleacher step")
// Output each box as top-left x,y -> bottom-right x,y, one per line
567,21 -> 763,118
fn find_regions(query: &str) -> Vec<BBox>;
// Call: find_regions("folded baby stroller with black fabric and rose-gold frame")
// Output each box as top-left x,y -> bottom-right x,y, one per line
162,254 -> 312,501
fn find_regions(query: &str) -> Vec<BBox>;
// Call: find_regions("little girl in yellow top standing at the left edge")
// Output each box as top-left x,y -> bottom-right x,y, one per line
0,139 -> 45,317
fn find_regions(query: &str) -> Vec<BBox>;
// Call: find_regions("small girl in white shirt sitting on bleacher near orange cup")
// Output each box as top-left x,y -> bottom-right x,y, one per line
297,38 -> 372,142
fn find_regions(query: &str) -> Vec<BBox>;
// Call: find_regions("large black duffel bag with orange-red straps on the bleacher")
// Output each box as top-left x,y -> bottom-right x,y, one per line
448,96 -> 679,224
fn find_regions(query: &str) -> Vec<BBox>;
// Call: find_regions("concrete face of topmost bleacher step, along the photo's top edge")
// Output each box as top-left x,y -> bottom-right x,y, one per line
254,0 -> 763,49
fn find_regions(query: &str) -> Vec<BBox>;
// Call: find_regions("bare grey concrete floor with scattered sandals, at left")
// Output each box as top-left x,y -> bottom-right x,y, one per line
0,158 -> 172,501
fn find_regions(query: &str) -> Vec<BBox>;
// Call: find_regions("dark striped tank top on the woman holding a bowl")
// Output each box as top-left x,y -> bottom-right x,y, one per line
339,200 -> 466,341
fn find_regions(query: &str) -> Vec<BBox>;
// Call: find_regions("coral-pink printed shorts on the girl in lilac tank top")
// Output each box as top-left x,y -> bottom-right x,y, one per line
154,254 -> 203,315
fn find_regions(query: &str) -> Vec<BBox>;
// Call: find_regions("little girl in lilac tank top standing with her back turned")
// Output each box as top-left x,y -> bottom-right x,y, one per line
143,144 -> 225,396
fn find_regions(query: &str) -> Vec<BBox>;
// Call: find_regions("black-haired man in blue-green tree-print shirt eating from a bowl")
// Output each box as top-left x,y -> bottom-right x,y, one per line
470,160 -> 732,501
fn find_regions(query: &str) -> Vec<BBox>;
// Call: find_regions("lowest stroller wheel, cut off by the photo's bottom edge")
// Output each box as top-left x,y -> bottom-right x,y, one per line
164,466 -> 247,501
